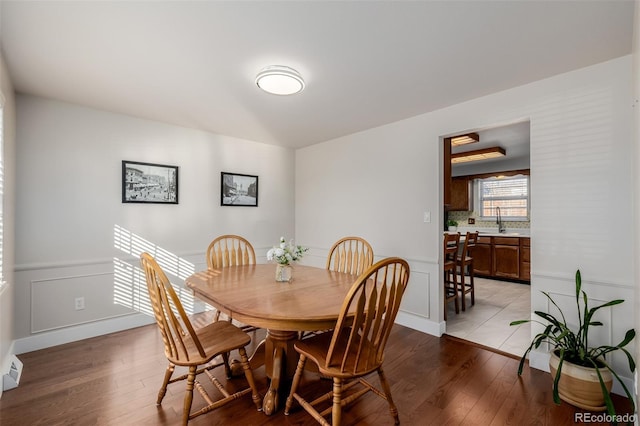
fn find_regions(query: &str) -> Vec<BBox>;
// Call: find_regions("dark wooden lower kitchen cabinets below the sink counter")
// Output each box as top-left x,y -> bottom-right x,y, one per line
473,236 -> 531,282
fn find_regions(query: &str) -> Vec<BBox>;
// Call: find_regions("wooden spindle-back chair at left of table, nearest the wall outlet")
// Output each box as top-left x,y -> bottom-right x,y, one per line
140,253 -> 262,425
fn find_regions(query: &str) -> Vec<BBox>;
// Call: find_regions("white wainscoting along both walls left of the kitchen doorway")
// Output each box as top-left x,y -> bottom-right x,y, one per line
14,247 -> 442,354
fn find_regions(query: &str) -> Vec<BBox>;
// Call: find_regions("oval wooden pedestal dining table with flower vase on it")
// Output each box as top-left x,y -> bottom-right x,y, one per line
185,264 -> 357,415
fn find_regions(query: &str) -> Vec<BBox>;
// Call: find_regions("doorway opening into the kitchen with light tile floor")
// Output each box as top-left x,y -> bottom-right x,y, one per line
441,121 -> 531,356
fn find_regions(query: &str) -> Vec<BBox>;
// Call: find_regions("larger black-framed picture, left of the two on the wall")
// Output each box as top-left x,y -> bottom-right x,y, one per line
122,161 -> 178,204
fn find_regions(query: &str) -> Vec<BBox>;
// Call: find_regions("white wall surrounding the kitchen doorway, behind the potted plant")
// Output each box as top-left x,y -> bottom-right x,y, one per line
296,56 -> 635,386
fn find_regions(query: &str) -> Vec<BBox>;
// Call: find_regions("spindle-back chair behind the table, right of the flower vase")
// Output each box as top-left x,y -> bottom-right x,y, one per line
326,237 -> 373,275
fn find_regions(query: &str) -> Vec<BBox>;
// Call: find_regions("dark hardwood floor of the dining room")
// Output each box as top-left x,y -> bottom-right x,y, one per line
0,316 -> 629,426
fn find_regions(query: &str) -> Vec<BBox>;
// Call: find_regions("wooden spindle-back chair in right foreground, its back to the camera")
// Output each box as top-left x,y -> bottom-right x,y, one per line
284,257 -> 409,426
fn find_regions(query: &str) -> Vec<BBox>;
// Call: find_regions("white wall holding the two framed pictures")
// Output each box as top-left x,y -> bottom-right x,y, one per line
15,95 -> 294,353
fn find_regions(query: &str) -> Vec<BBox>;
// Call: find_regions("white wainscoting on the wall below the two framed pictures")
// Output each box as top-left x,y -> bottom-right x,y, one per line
14,253 -> 206,354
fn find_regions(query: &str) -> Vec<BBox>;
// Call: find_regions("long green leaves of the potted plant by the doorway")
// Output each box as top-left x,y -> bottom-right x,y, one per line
511,270 -> 636,415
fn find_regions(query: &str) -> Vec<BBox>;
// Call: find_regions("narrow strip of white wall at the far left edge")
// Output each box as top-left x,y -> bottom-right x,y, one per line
0,51 -> 16,396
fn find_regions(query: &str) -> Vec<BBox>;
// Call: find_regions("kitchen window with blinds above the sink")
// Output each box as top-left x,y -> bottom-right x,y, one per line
478,175 -> 529,220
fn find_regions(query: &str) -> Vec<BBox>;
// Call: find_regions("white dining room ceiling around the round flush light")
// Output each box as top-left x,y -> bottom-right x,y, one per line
0,0 -> 634,147
